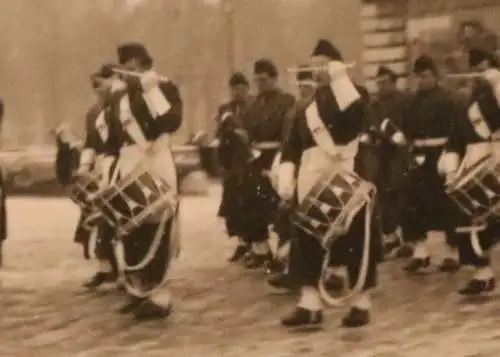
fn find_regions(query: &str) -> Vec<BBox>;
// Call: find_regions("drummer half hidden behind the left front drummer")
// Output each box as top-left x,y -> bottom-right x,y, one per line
71,65 -> 124,289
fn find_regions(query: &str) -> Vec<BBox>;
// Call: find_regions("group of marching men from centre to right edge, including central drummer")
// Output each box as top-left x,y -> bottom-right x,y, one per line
217,40 -> 500,328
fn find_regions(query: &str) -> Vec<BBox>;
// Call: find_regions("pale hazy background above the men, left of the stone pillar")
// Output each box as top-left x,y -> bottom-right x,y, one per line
0,0 -> 362,148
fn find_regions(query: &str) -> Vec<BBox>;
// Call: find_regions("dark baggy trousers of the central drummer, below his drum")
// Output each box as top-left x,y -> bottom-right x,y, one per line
294,208 -> 381,289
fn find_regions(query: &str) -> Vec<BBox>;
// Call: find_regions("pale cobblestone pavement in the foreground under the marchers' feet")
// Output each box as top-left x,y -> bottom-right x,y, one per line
0,185 -> 500,357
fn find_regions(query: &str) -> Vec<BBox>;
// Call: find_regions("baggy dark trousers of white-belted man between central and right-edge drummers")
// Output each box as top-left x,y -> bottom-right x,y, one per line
399,159 -> 457,247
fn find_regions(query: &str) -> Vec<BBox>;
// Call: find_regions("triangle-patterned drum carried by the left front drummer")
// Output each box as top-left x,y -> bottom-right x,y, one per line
93,165 -> 177,236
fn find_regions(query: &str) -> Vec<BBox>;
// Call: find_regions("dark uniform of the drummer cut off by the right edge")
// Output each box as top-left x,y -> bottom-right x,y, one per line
446,79 -> 500,266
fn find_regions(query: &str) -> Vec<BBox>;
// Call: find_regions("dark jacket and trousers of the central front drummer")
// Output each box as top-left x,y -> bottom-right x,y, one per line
282,87 -> 379,288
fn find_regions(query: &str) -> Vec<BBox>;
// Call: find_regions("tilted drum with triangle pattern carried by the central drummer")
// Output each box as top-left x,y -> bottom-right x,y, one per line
291,170 -> 376,250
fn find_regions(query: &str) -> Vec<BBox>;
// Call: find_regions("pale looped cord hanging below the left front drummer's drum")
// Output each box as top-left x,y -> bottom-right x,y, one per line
115,209 -> 178,298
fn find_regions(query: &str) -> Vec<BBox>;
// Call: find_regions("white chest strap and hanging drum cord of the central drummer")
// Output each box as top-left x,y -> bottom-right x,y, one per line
305,100 -> 374,306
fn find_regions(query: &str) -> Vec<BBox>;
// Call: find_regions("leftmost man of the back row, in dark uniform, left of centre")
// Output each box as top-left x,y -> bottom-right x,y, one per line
216,72 -> 254,262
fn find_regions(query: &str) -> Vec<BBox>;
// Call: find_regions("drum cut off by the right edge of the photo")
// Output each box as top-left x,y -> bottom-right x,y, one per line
446,155 -> 500,223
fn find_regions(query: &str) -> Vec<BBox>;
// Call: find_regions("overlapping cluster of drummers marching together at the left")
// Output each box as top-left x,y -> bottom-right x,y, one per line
56,43 -> 182,320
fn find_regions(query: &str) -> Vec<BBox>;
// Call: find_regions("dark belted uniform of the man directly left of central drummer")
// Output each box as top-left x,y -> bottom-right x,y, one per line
236,89 -> 295,242
